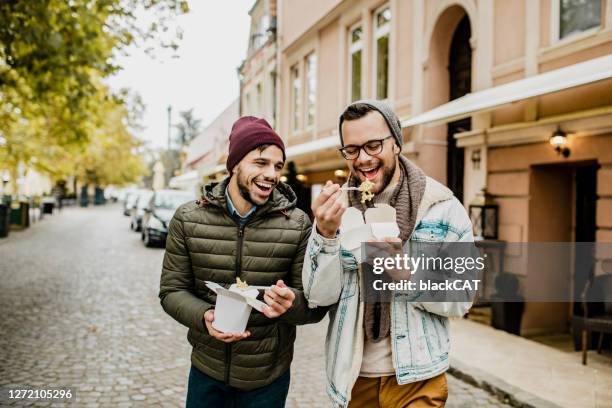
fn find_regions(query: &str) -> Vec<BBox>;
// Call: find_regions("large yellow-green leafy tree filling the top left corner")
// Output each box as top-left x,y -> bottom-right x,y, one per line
0,0 -> 188,193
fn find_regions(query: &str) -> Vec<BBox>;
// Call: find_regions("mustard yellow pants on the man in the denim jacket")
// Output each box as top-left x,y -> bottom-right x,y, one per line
349,373 -> 448,408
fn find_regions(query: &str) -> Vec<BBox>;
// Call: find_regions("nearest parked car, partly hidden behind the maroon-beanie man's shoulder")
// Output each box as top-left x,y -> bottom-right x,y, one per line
141,190 -> 197,247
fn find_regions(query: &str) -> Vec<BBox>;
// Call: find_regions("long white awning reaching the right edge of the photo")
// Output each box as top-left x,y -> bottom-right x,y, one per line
402,55 -> 612,128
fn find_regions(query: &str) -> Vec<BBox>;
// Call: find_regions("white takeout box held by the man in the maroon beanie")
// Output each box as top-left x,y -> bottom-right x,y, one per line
206,281 -> 265,333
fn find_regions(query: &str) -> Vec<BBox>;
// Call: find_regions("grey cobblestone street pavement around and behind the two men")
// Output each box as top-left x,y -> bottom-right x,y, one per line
0,205 -> 503,408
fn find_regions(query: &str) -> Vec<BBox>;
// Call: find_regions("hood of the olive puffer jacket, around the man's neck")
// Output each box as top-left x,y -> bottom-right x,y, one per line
202,176 -> 297,214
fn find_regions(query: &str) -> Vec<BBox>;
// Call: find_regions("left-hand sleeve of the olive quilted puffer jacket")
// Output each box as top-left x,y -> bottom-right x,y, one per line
159,208 -> 213,332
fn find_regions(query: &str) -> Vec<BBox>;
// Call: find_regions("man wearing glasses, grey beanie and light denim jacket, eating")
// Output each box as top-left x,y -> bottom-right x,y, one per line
302,100 -> 473,408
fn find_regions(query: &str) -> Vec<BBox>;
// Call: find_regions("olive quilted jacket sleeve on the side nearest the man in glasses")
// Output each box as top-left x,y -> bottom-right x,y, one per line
280,213 -> 327,325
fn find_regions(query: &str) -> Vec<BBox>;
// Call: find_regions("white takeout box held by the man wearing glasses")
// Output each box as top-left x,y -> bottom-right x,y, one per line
340,204 -> 400,262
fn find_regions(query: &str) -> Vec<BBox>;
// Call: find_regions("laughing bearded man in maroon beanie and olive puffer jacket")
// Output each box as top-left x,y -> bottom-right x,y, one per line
159,116 -> 326,408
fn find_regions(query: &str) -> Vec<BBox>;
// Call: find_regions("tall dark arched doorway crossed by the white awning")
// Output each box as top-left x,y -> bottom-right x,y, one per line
446,15 -> 472,201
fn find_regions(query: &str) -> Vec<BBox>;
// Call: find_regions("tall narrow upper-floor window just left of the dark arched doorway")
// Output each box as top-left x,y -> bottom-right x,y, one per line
374,6 -> 391,99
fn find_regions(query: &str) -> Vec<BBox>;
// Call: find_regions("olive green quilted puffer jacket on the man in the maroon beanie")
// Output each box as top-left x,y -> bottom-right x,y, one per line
159,179 -> 325,390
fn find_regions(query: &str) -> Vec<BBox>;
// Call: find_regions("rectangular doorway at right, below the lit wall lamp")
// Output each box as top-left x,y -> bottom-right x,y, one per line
523,161 -> 599,342
